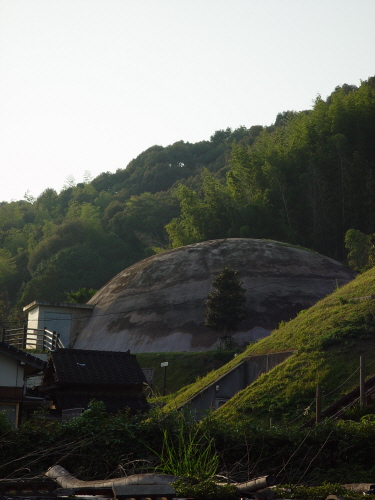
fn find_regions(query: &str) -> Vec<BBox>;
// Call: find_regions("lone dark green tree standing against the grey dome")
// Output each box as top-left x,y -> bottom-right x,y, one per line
205,267 -> 246,342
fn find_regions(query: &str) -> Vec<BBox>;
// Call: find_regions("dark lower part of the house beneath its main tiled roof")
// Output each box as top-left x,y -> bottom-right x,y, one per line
53,391 -> 149,413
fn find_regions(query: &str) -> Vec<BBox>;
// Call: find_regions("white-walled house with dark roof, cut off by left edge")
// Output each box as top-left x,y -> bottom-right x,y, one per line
0,342 -> 46,428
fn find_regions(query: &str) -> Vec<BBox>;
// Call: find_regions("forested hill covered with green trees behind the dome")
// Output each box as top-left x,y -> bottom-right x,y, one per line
0,77 -> 375,324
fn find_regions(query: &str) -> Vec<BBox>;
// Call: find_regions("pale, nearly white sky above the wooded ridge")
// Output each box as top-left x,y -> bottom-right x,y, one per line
0,0 -> 375,201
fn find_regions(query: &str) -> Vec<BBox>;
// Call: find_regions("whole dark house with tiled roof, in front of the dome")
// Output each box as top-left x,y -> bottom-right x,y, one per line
38,349 -> 149,416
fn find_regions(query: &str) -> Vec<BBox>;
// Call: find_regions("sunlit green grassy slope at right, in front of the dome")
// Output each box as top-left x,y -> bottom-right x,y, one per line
167,269 -> 375,423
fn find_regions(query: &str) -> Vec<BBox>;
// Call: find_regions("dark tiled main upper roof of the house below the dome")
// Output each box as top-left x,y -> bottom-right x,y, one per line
48,349 -> 146,388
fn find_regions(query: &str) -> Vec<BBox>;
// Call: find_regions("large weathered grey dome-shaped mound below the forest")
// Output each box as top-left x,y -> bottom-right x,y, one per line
74,238 -> 356,353
